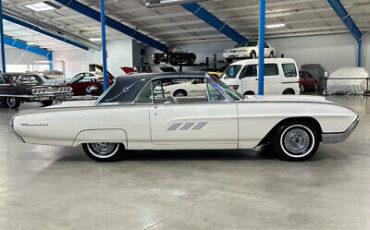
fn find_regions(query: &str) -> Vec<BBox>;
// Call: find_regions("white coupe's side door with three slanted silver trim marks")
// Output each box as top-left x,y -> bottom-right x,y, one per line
150,77 -> 238,149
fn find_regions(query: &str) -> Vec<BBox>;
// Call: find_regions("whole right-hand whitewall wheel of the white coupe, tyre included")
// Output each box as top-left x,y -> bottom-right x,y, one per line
272,122 -> 320,161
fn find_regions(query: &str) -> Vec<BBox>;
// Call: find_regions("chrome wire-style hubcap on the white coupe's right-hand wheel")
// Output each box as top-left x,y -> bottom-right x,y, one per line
284,128 -> 311,155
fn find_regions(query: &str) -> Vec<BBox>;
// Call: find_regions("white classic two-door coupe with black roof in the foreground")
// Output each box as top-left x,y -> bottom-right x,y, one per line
11,73 -> 359,161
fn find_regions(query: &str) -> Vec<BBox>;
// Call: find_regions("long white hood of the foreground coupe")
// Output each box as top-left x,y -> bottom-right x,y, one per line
243,95 -> 333,104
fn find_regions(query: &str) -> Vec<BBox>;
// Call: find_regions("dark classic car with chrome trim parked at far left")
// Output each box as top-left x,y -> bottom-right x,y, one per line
0,73 -> 72,109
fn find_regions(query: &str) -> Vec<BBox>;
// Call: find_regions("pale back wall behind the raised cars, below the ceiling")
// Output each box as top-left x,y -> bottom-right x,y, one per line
147,34 -> 370,72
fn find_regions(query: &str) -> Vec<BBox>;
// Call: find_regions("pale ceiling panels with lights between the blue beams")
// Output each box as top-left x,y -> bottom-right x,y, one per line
3,0 -> 370,50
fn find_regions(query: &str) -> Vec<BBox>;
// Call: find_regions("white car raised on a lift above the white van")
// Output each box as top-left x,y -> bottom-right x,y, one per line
223,41 -> 276,62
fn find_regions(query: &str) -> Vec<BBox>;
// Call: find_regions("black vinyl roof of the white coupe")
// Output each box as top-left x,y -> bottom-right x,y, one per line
100,72 -> 206,103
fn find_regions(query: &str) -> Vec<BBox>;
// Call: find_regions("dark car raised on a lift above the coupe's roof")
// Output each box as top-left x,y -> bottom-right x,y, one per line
153,48 -> 197,65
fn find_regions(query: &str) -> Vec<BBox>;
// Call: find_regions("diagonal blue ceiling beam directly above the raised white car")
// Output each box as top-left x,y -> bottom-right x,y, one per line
182,2 -> 248,44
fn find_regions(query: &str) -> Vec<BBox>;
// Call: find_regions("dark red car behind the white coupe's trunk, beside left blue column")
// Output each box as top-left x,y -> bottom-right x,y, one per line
67,72 -> 113,96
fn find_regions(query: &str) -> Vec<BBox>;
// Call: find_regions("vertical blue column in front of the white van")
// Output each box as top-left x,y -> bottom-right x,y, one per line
258,0 -> 266,95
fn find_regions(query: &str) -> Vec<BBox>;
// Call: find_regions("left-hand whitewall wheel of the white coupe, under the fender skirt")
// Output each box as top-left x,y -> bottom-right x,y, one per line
82,142 -> 124,162
